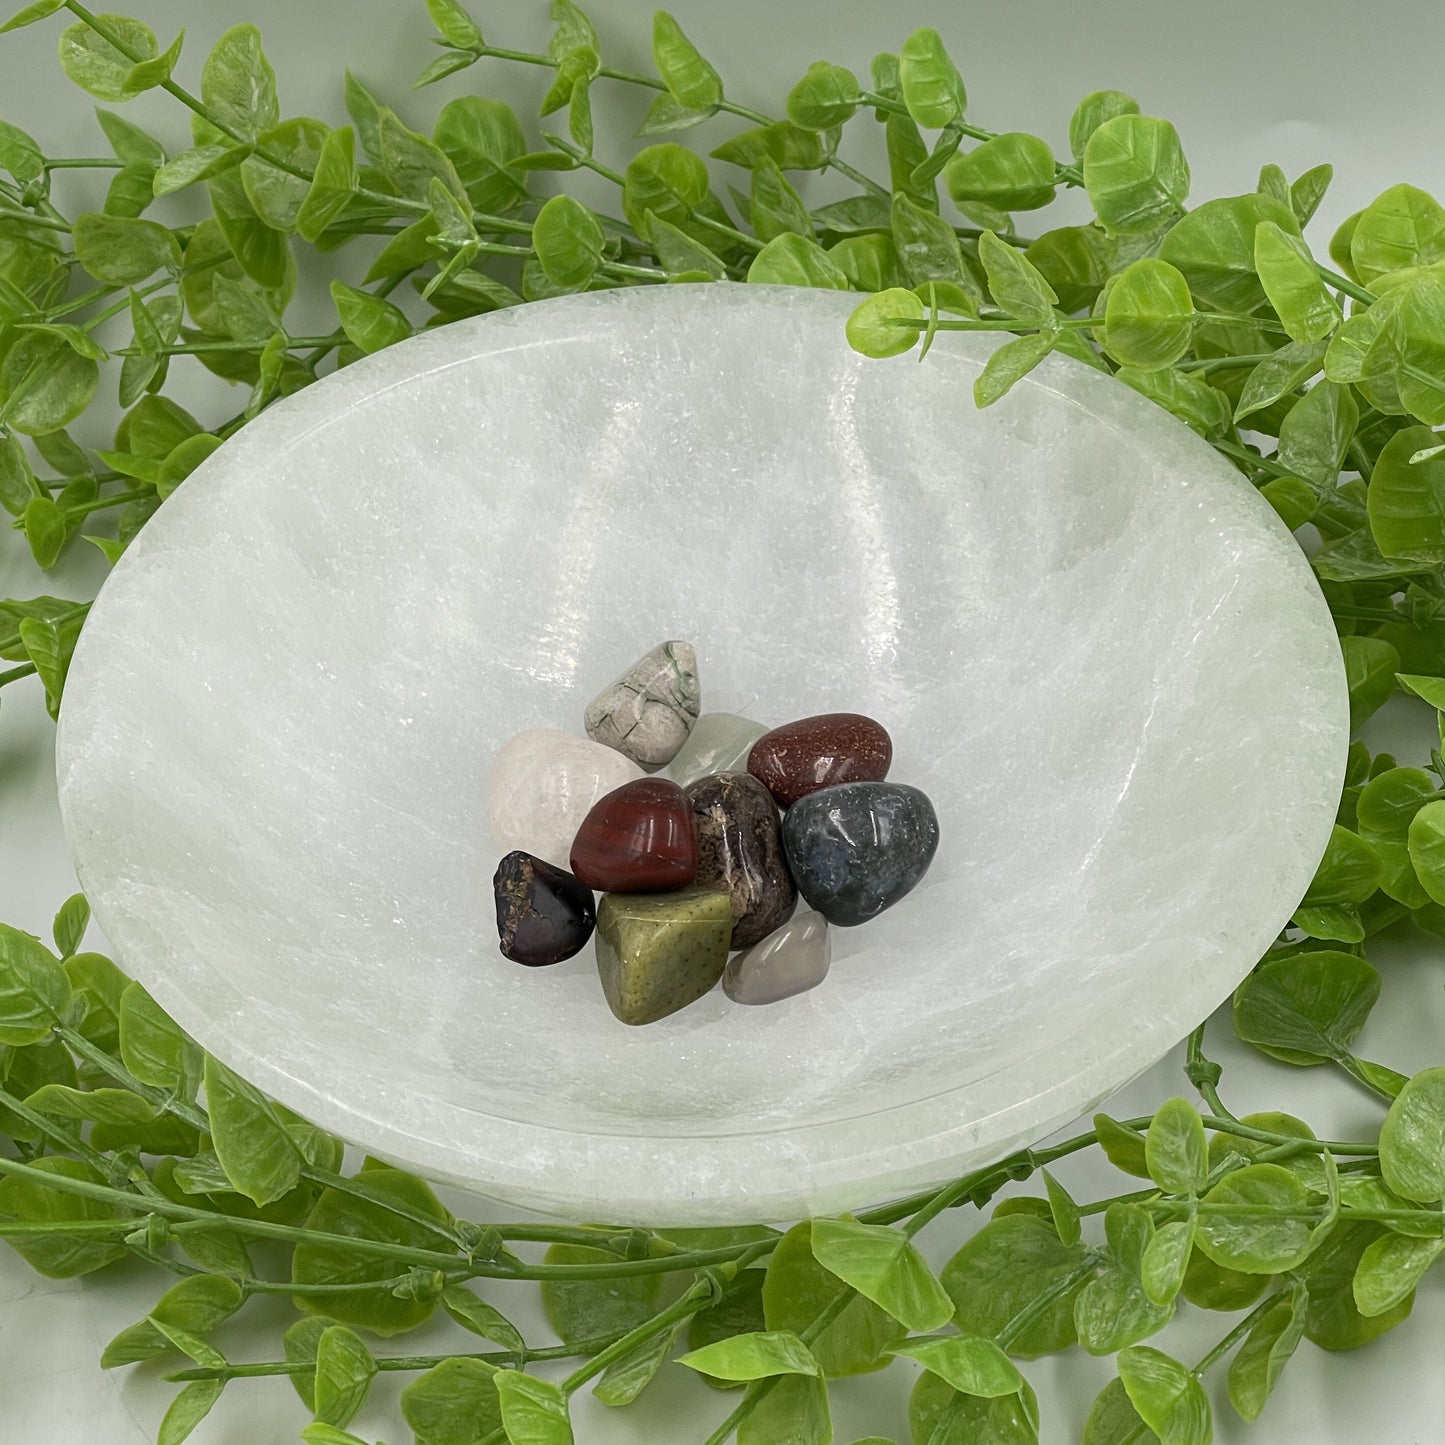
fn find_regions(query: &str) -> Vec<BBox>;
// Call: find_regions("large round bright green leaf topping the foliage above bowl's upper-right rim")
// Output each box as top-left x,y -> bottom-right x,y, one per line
1084,111 -> 1184,235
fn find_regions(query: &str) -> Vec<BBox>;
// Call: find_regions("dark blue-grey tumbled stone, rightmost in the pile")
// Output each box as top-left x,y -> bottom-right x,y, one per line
783,783 -> 938,928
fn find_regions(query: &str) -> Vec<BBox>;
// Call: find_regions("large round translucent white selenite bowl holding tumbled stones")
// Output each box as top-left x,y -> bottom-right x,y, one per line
59,285 -> 1347,1224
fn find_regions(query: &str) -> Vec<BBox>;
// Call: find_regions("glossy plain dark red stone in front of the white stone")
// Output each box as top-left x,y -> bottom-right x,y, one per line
572,777 -> 698,893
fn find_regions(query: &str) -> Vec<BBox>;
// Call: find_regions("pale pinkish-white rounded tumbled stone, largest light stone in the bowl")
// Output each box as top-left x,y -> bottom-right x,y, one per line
487,728 -> 643,868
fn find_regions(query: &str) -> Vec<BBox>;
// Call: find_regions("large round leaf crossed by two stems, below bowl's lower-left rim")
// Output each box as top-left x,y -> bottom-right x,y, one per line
292,1156 -> 451,1337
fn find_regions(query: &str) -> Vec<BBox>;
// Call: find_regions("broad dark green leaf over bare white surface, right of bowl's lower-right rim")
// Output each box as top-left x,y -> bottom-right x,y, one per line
1234,949 -> 1380,1065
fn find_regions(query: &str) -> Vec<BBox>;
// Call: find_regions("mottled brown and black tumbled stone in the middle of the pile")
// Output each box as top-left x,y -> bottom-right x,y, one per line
686,773 -> 798,948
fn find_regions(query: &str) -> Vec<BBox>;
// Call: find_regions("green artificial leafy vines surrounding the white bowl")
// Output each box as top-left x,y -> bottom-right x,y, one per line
0,0 -> 1445,1445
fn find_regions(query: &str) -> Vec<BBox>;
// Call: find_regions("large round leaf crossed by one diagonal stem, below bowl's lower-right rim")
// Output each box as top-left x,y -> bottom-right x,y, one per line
941,1214 -> 1084,1360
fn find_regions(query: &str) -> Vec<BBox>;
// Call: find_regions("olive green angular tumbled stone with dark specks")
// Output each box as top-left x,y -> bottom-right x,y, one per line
594,889 -> 733,1023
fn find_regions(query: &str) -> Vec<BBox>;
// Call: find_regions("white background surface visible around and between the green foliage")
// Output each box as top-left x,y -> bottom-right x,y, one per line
0,0 -> 1445,1445
